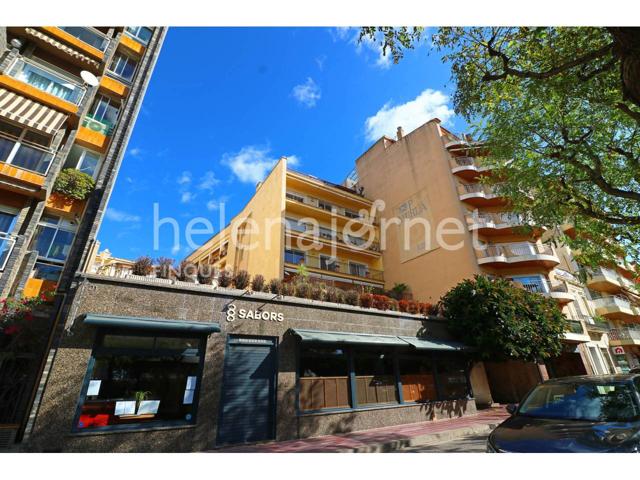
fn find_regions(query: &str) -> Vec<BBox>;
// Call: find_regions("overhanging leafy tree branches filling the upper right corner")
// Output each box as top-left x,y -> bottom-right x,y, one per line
361,27 -> 640,265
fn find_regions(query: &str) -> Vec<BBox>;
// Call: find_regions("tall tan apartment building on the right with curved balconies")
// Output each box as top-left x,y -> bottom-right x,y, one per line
352,119 -> 640,399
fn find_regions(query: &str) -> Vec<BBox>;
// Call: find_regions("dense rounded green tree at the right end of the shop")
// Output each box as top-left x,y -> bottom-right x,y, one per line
440,275 -> 567,361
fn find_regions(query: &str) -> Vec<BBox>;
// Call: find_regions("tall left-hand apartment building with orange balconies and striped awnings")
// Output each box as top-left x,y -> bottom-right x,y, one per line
0,27 -> 166,446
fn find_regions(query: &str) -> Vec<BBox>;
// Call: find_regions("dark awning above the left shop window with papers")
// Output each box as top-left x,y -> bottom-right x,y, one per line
84,313 -> 220,334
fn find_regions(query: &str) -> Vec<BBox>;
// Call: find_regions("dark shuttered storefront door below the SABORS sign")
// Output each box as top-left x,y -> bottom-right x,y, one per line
217,335 -> 277,445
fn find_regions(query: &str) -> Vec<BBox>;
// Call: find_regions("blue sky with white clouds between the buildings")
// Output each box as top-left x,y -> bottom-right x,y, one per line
98,27 -> 464,259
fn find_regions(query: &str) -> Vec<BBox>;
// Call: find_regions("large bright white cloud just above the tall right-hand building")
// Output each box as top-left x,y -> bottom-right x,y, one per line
365,88 -> 454,142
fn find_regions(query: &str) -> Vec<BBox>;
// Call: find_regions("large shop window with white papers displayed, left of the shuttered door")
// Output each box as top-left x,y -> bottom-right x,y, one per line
75,331 -> 206,430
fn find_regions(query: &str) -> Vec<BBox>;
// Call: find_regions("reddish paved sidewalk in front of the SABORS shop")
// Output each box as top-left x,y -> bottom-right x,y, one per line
215,407 -> 509,453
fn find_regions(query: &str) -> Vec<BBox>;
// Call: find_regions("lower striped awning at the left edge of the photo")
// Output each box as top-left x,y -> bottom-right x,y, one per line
0,88 -> 67,135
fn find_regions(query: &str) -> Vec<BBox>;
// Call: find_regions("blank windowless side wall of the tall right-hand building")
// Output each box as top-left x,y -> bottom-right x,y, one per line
356,121 -> 480,302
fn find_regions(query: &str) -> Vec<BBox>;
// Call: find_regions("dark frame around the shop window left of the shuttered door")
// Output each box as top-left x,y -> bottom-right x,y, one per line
71,327 -> 207,435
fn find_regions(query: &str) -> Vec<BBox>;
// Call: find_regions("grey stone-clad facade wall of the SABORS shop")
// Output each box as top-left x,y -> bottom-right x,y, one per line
28,275 -> 476,452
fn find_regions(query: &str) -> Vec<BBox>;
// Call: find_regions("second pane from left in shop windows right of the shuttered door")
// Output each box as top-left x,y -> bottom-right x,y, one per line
354,350 -> 399,405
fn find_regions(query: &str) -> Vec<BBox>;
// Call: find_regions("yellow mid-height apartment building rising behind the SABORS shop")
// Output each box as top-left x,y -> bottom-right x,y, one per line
186,158 -> 384,289
